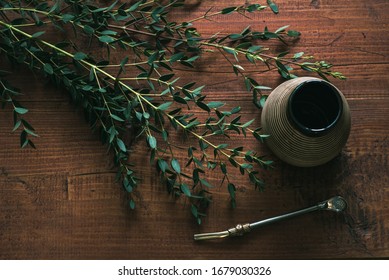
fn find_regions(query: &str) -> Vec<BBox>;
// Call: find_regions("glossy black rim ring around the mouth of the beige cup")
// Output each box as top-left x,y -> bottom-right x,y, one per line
287,80 -> 343,136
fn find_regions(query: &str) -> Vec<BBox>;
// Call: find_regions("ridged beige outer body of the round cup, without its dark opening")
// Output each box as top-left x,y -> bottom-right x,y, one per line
261,77 -> 351,167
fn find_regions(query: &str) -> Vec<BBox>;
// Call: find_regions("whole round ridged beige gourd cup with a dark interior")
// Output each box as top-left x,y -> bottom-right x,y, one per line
261,77 -> 351,167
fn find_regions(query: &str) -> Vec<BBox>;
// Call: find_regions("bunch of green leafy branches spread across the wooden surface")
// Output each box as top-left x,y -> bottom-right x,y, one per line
0,0 -> 344,223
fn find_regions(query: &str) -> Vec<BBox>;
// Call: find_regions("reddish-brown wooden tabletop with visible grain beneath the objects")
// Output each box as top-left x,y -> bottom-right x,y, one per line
0,0 -> 389,259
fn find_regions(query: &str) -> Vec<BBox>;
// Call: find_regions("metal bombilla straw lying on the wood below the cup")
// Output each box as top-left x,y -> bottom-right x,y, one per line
194,196 -> 347,240
